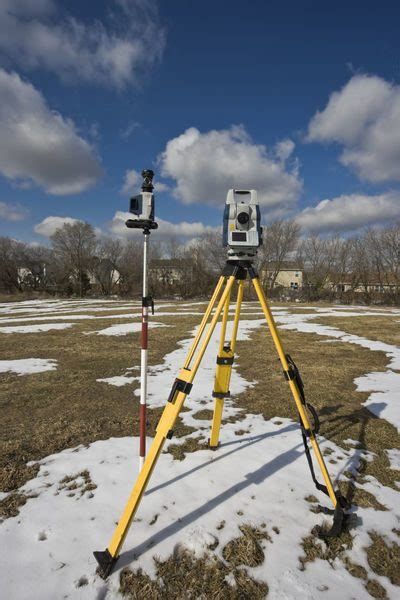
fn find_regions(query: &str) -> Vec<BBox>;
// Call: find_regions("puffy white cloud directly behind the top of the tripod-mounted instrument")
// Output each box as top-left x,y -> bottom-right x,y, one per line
159,126 -> 302,209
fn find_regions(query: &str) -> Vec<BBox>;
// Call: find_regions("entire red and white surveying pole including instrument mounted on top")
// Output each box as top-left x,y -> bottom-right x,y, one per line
126,169 -> 158,471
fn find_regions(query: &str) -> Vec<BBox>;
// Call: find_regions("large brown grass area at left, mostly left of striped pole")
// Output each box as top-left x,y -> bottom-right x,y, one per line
0,311 -> 198,505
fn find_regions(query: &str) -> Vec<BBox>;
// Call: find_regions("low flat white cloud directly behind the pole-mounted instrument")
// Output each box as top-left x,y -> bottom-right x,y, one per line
108,210 -> 220,238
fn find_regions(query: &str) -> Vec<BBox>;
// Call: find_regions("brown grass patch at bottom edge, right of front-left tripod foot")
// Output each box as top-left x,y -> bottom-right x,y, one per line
120,548 -> 268,600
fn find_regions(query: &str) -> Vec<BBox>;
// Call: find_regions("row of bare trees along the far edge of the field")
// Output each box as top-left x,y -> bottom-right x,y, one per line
0,220 -> 400,304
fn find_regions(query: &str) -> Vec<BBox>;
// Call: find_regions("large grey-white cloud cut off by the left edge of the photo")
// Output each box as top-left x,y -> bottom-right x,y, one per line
0,69 -> 101,195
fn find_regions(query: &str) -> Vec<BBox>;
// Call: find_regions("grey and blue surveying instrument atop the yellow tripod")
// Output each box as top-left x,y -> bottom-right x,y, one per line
222,190 -> 262,261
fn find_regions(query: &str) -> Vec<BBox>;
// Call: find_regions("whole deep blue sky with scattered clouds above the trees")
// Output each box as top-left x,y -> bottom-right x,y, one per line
0,0 -> 400,243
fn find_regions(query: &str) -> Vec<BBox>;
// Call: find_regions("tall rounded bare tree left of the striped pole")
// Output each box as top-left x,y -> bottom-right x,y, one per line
50,221 -> 96,297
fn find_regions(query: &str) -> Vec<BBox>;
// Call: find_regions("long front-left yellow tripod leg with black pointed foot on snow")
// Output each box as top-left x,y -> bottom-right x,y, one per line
94,271 -> 236,578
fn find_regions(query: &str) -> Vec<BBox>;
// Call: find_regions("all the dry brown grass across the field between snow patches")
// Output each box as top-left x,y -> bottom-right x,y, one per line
0,302 -> 400,599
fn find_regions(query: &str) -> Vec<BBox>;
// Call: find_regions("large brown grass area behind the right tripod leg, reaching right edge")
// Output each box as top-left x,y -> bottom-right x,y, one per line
235,328 -> 400,491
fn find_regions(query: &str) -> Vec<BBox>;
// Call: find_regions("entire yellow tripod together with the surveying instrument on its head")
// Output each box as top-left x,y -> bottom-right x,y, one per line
94,190 -> 348,578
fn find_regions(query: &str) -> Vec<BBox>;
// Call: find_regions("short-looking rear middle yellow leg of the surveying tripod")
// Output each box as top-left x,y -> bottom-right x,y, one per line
210,280 -> 243,448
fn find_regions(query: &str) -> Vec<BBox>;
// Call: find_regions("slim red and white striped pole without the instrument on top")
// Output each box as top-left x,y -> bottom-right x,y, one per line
139,229 -> 154,469
